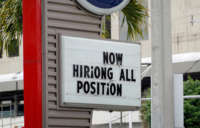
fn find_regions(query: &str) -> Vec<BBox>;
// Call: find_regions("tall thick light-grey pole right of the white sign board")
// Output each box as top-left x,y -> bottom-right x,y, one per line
151,0 -> 174,128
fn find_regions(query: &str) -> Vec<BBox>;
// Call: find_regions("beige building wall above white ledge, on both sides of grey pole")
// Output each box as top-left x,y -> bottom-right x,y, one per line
140,0 -> 200,57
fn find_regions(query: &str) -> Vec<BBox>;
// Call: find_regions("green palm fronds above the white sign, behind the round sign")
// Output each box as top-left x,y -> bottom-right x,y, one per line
102,0 -> 148,40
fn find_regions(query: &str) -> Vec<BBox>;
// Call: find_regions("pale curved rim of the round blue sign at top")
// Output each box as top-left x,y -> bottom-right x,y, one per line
77,0 -> 130,15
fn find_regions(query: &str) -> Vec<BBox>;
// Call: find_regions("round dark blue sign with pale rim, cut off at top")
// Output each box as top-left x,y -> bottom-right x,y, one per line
77,0 -> 130,15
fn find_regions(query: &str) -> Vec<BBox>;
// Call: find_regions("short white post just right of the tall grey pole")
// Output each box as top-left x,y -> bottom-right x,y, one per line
174,74 -> 184,128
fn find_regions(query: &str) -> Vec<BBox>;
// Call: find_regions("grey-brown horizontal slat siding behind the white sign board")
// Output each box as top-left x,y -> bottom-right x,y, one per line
45,0 -> 101,128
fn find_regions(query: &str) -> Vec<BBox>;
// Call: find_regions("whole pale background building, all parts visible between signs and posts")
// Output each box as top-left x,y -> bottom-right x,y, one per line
0,0 -> 200,128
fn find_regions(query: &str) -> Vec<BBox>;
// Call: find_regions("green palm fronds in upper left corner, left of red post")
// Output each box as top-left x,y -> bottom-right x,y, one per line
0,0 -> 22,56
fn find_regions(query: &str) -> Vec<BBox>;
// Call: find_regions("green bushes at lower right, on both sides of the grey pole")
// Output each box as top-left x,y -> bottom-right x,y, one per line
141,78 -> 200,128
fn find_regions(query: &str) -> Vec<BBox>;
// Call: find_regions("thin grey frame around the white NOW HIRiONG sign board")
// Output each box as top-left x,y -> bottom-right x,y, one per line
58,34 -> 141,111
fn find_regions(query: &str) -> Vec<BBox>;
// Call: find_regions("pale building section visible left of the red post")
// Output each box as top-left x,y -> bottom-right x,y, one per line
0,44 -> 24,128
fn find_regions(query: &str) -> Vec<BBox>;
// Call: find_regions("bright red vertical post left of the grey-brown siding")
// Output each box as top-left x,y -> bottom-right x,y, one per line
23,0 -> 42,128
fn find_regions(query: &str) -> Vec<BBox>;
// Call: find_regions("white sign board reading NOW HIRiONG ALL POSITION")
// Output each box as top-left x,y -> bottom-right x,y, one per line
60,36 -> 141,110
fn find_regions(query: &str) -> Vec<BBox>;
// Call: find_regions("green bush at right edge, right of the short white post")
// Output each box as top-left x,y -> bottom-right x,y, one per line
184,78 -> 200,128
